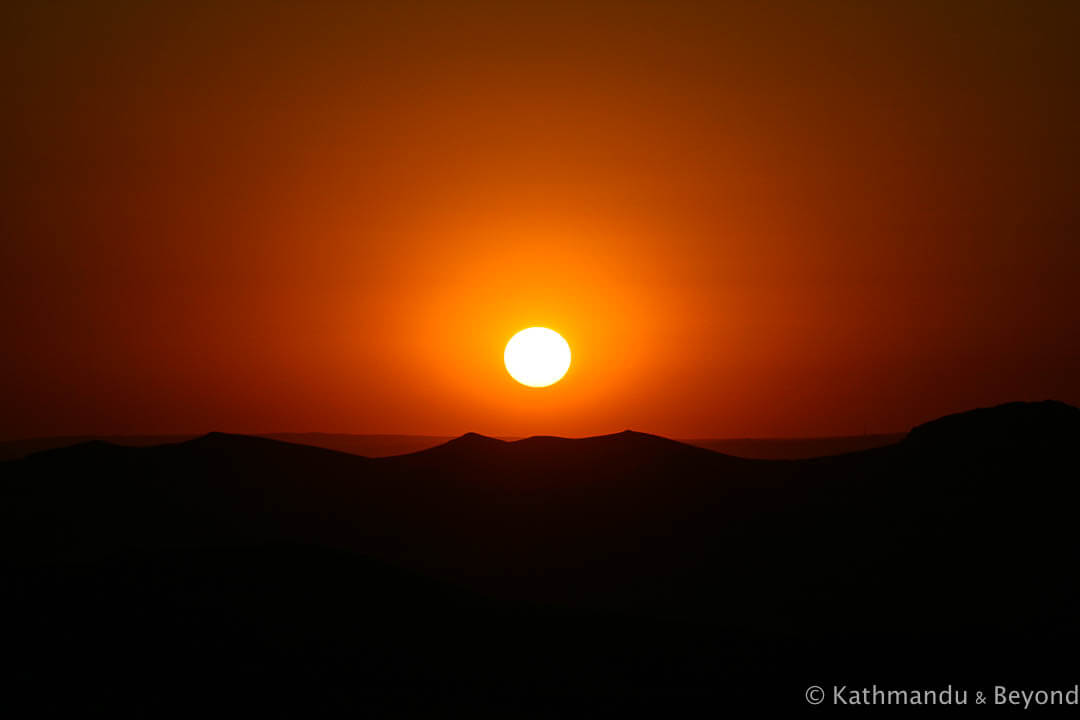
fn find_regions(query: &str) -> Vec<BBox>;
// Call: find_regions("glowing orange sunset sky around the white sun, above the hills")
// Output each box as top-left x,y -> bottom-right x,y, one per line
0,0 -> 1080,438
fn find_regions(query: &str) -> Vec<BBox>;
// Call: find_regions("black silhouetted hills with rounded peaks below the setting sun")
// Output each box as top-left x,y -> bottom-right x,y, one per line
0,403 -> 1080,717
